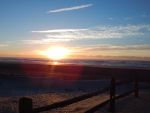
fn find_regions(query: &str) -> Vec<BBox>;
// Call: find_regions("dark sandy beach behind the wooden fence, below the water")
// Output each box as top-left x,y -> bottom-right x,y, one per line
0,64 -> 150,113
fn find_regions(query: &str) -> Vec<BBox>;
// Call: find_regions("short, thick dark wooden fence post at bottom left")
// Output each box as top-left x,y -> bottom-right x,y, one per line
19,97 -> 33,113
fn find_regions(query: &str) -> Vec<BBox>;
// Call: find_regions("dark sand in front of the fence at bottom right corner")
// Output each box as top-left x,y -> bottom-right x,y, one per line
96,90 -> 150,113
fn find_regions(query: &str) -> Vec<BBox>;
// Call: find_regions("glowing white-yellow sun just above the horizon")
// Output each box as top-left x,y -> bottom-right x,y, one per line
41,46 -> 69,60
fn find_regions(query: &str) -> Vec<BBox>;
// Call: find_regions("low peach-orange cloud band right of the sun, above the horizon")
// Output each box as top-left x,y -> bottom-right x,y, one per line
71,44 -> 150,58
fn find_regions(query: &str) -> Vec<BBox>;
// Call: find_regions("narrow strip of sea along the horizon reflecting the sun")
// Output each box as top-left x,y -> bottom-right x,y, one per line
0,58 -> 150,67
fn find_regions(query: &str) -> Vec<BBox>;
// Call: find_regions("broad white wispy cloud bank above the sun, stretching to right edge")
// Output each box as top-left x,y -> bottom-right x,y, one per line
29,24 -> 150,44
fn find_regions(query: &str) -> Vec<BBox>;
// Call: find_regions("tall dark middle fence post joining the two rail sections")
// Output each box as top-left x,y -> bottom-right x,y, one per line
109,78 -> 116,113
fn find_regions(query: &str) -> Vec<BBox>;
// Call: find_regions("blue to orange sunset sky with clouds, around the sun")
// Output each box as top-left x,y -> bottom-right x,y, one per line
0,0 -> 150,59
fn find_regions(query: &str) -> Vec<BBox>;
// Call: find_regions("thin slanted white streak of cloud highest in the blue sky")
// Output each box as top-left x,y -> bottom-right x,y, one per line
48,4 -> 93,13
